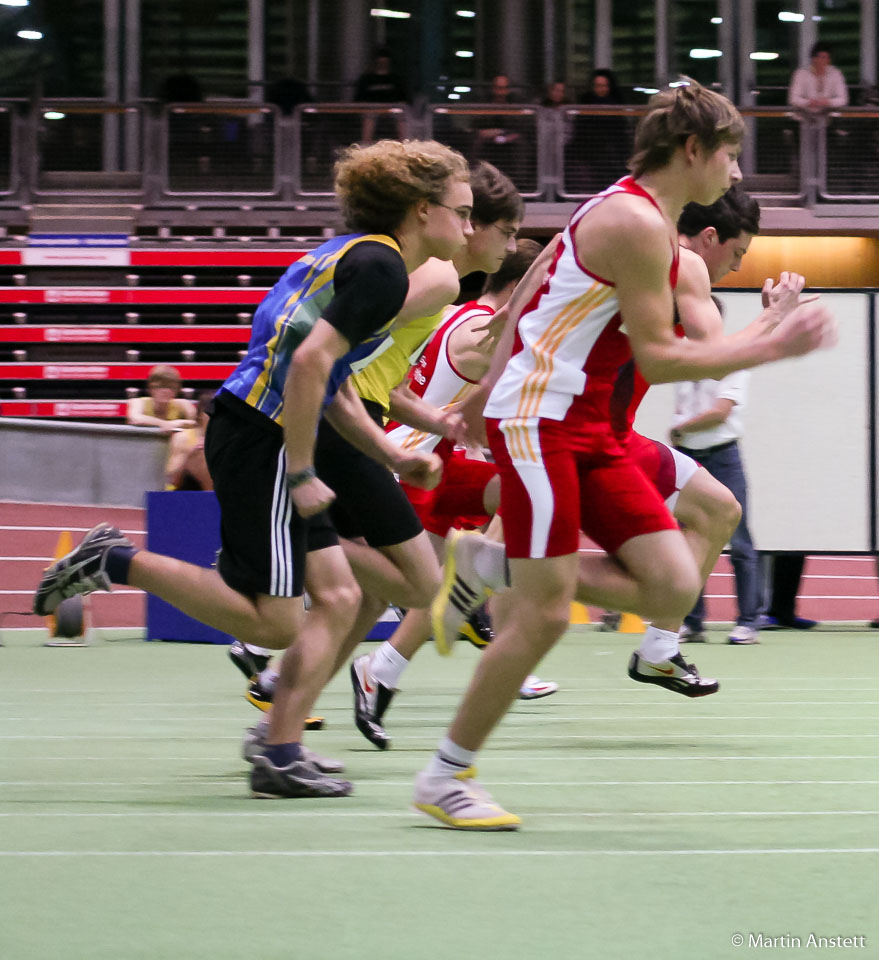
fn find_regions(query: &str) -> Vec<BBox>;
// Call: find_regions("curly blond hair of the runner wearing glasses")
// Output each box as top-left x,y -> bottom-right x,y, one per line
334,140 -> 469,233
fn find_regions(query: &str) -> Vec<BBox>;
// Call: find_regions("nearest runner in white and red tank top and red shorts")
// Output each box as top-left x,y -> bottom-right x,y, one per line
414,83 -> 834,830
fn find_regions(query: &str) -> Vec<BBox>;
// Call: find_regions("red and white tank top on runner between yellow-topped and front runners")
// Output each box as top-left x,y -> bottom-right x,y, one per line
385,300 -> 494,452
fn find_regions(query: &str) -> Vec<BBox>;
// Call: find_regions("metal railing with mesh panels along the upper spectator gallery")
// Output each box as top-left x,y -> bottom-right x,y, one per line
0,100 -> 879,209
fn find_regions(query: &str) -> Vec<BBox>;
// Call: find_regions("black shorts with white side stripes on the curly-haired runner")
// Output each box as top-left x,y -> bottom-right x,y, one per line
205,394 -> 339,597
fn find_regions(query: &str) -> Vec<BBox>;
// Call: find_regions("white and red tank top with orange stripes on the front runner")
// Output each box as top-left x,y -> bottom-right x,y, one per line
485,177 -> 678,436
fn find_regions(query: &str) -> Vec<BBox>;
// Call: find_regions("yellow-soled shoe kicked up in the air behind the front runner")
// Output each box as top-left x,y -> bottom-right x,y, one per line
430,530 -> 489,657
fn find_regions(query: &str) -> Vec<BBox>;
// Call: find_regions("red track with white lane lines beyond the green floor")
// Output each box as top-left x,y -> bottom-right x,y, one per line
0,501 -> 879,628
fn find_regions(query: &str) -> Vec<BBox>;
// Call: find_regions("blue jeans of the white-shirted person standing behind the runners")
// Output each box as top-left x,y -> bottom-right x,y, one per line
679,442 -> 763,630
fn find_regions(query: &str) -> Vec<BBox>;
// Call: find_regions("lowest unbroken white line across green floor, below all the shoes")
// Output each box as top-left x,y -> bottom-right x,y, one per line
0,847 -> 879,858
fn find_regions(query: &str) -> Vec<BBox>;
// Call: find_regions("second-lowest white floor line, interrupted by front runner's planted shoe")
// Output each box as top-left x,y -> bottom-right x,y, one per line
0,810 -> 879,820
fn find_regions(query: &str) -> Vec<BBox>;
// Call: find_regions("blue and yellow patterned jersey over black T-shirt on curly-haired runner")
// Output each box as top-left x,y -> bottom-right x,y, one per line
221,233 -> 405,424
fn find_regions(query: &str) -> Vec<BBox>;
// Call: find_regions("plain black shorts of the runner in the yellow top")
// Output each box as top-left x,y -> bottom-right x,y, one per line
314,400 -> 424,547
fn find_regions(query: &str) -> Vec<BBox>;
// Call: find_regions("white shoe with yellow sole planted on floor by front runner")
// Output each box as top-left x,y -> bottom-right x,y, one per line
413,767 -> 522,830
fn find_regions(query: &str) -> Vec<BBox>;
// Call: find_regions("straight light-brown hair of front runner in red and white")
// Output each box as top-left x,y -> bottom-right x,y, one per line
629,80 -> 745,177
